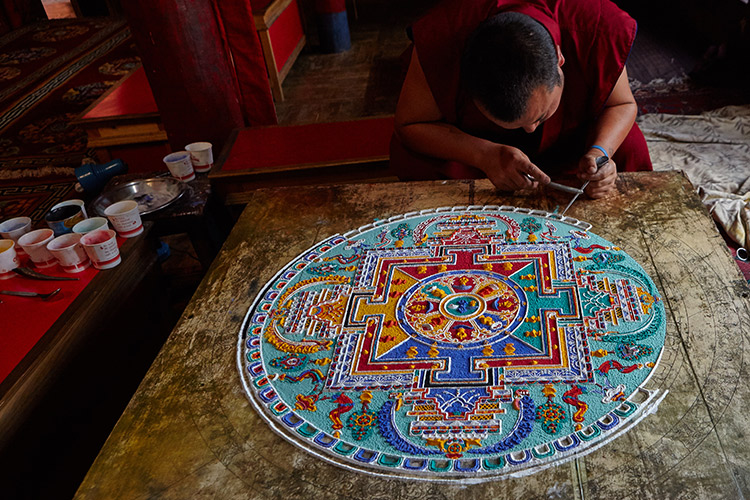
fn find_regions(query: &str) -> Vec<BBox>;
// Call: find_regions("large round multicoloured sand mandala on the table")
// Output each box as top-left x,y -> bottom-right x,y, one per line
238,207 -> 665,480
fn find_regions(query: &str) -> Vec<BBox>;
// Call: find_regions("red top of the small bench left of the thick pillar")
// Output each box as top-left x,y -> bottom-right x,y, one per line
83,67 -> 159,120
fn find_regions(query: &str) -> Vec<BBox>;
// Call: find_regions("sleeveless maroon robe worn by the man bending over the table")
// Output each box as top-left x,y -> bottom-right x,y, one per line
391,0 -> 652,179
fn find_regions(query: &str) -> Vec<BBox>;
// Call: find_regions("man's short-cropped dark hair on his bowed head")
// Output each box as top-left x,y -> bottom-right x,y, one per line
461,12 -> 561,122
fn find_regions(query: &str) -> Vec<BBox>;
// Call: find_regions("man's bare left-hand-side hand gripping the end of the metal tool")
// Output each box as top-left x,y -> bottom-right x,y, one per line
480,144 -> 550,191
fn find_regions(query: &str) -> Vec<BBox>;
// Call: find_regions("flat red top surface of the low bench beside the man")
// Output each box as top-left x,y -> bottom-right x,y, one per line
221,116 -> 393,172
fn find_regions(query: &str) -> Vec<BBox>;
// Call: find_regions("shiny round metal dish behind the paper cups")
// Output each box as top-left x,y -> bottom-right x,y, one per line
91,177 -> 187,217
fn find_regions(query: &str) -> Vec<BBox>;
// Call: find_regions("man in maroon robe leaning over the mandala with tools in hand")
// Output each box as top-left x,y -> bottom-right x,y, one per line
391,0 -> 652,198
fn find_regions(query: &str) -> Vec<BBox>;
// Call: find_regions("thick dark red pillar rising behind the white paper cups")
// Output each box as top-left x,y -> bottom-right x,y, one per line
123,0 -> 275,150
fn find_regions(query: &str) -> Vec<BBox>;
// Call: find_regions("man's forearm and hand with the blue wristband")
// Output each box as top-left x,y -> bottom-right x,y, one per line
578,65 -> 638,198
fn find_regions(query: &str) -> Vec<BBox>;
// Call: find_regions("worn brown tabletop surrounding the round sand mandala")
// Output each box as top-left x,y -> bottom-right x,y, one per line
77,172 -> 750,500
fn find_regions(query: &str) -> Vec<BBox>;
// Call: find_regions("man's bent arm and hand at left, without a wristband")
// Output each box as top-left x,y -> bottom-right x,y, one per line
395,50 -> 549,190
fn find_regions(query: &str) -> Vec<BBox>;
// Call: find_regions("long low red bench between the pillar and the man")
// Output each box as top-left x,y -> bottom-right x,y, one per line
208,115 -> 398,205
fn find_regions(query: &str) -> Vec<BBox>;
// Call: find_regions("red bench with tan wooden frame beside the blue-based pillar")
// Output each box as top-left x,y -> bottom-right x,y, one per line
250,0 -> 305,101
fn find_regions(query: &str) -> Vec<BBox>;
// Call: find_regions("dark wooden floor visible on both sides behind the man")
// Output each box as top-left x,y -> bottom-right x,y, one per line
276,0 -> 706,125
